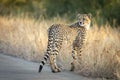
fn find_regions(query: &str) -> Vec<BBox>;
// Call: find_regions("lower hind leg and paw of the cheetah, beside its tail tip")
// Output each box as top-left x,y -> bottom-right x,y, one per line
49,54 -> 61,73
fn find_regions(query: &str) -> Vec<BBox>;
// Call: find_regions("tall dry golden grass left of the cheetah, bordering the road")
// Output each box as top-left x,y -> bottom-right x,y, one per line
0,17 -> 48,61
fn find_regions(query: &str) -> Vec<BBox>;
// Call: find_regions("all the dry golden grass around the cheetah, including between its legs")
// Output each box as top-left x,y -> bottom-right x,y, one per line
0,17 -> 120,79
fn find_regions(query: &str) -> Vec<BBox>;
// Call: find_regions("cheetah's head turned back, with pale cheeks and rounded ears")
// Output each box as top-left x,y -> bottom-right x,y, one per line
77,13 -> 91,30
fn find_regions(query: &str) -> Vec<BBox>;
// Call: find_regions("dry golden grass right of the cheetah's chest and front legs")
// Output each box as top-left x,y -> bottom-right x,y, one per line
78,25 -> 120,78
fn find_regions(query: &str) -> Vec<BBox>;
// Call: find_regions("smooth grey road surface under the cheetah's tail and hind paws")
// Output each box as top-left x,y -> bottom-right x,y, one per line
0,54 -> 98,80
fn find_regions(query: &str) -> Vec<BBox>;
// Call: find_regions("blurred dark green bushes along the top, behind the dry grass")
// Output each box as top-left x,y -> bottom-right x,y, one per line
0,0 -> 120,26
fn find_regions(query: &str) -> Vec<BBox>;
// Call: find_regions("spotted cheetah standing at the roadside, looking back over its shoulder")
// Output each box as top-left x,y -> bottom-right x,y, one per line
38,13 -> 91,73
